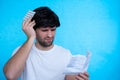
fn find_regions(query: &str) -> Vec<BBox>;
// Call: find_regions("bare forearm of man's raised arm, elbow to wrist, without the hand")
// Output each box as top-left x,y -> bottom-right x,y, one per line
4,38 -> 34,80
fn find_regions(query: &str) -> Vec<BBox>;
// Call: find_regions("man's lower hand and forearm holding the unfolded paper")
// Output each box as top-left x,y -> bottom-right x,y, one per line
65,72 -> 89,80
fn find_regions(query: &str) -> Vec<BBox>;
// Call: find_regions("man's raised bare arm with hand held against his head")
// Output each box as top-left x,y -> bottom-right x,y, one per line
4,18 -> 36,80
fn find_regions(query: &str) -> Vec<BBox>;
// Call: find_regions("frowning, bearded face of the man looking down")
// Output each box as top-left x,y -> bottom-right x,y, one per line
36,27 -> 56,47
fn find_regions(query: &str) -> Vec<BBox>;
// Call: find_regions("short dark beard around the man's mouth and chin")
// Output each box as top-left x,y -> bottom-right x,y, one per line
37,37 -> 54,47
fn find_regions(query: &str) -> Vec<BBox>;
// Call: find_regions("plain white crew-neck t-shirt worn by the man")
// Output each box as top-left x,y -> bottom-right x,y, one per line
13,45 -> 71,80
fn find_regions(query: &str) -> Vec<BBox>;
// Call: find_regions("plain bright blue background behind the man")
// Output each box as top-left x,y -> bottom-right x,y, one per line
0,0 -> 120,80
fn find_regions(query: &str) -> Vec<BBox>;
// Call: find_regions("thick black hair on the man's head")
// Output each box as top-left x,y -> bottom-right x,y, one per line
32,7 -> 60,29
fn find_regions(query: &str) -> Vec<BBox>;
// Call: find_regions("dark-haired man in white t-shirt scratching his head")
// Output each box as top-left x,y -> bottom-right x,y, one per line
4,7 -> 88,80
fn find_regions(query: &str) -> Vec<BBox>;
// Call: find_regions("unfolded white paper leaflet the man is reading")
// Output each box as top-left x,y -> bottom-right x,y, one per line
64,53 -> 91,74
